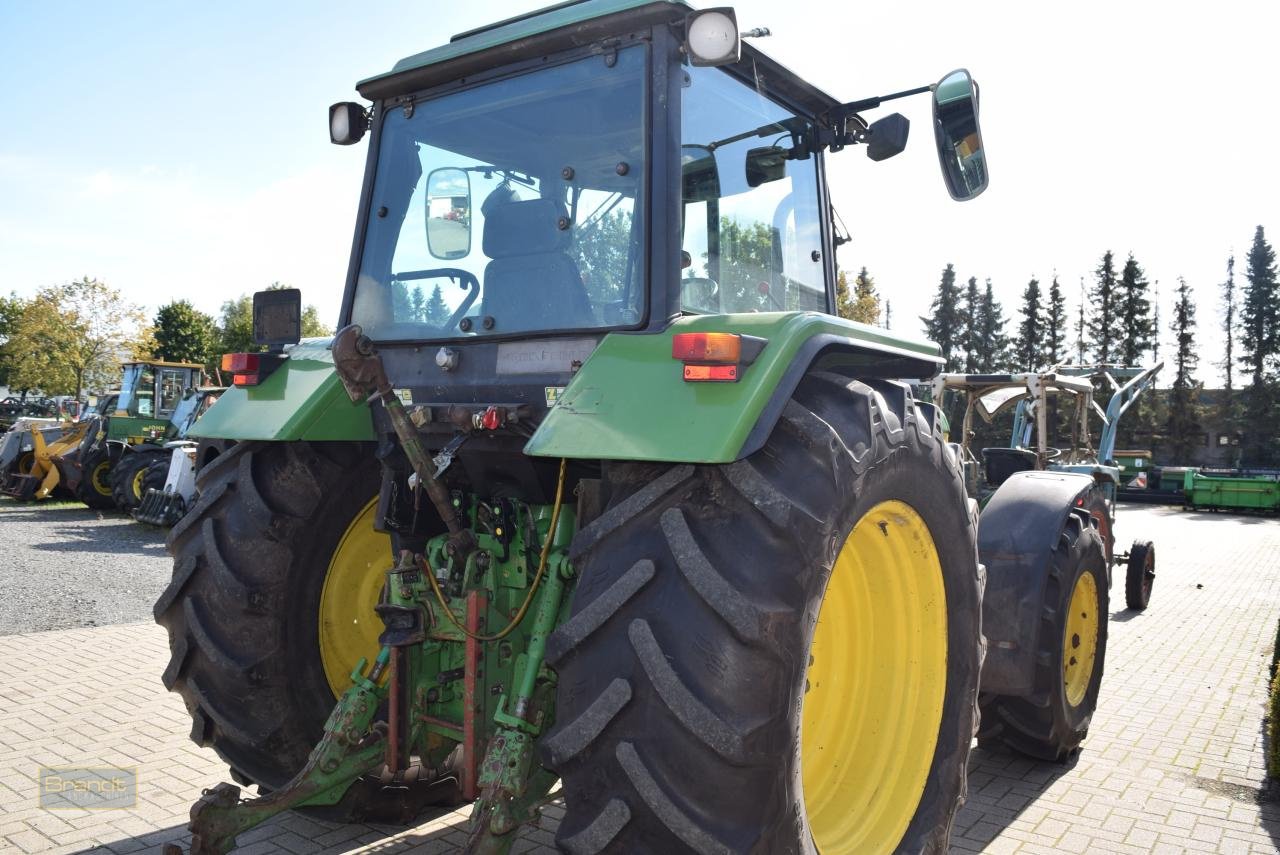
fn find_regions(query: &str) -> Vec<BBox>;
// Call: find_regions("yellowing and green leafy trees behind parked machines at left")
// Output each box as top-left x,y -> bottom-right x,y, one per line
0,276 -> 333,399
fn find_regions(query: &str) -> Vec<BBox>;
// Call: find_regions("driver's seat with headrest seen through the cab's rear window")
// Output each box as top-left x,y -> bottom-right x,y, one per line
480,198 -> 595,333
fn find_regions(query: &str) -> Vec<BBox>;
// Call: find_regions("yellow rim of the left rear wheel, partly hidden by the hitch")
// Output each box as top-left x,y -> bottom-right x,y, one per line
320,498 -> 392,698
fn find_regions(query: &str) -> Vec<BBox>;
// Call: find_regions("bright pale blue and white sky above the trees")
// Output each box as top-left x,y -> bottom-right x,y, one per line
0,0 -> 1280,383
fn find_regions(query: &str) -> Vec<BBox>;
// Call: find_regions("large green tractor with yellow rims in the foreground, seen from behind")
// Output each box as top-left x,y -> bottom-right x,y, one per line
155,0 -> 998,855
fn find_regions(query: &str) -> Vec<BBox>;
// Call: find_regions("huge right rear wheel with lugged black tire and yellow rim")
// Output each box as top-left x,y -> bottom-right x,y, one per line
540,374 -> 983,855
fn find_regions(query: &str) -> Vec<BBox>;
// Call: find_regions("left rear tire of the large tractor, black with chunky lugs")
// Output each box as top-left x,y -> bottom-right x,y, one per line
155,443 -> 392,788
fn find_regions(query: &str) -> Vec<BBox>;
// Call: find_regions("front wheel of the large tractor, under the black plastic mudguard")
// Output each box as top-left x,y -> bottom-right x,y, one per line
978,509 -> 1110,763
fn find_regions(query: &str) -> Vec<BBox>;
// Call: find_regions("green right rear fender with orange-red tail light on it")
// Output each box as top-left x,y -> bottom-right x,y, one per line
525,312 -> 942,463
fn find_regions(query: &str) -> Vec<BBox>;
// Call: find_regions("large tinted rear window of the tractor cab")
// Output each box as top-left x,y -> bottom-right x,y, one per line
352,45 -> 648,340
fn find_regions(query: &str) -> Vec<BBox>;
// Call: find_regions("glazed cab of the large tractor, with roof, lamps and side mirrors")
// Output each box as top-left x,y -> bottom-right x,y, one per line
312,1 -> 987,434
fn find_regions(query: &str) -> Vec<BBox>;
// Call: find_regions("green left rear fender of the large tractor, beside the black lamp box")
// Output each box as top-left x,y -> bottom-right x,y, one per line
187,338 -> 374,442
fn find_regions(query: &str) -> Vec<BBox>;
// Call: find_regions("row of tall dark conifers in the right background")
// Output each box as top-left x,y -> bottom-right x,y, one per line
920,225 -> 1280,467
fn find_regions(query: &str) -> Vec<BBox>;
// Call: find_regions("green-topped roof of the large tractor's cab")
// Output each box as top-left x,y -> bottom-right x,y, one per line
356,0 -> 841,116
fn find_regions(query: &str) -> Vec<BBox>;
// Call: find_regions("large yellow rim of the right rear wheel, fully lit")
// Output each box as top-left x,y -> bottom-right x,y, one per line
800,502 -> 947,855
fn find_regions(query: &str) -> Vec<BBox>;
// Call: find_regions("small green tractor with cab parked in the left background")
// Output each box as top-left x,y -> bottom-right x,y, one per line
54,360 -> 204,512
